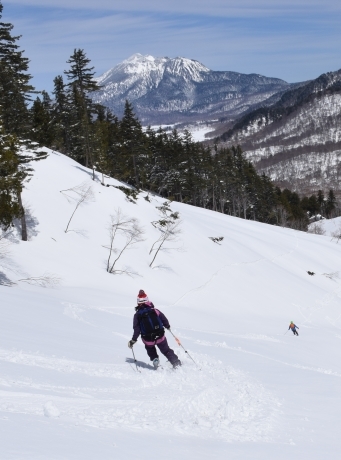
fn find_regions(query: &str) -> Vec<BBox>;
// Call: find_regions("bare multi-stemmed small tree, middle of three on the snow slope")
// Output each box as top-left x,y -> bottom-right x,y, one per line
105,208 -> 144,274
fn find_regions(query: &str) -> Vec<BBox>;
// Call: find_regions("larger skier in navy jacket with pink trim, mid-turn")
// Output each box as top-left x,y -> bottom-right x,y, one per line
128,289 -> 181,367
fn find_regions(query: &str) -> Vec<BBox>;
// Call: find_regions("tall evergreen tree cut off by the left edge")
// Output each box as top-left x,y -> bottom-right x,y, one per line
0,0 -> 46,241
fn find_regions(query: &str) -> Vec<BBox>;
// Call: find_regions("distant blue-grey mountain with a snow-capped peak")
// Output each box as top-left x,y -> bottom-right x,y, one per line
93,54 -> 290,124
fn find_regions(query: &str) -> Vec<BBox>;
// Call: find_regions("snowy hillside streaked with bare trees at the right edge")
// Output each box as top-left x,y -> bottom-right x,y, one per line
216,70 -> 341,193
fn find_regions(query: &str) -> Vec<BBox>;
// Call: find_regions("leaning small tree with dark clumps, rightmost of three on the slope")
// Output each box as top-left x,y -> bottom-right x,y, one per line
149,201 -> 181,267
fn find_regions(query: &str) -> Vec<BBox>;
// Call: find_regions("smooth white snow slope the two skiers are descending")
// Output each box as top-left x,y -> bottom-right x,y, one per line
0,151 -> 341,460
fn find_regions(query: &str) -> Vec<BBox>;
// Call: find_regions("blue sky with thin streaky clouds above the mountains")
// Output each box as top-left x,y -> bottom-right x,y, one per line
2,0 -> 341,91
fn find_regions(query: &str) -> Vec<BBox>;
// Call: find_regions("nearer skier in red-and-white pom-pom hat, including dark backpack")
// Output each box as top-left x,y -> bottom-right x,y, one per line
128,289 -> 181,369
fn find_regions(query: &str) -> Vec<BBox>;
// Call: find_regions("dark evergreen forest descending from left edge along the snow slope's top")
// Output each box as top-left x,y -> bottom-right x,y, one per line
0,2 -> 335,239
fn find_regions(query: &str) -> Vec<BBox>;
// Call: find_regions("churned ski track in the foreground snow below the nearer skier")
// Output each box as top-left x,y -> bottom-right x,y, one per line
0,350 -> 281,442
